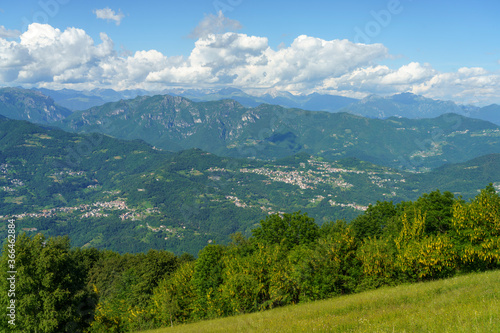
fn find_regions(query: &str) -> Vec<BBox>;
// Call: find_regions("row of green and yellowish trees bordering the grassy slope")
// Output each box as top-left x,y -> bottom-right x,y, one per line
0,185 -> 500,332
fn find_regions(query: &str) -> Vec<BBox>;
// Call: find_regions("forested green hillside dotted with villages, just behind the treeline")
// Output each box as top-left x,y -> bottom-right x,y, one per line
0,118 -> 500,254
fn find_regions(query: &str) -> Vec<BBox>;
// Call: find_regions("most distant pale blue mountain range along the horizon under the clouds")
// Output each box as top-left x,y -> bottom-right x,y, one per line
28,88 -> 500,125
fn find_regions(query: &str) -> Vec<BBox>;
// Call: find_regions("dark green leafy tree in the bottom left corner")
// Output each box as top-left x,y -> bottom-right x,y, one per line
0,233 -> 95,332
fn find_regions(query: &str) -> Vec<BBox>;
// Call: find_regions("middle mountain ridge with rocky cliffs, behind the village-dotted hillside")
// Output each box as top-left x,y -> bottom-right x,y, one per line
57,95 -> 500,170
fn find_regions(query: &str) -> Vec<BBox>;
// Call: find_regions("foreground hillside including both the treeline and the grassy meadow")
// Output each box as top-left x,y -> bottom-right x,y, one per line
0,186 -> 500,333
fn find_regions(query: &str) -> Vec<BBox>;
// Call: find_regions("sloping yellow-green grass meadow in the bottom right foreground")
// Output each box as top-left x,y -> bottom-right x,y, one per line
143,271 -> 500,333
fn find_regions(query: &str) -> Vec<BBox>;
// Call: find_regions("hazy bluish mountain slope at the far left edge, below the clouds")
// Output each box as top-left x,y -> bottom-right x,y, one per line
0,88 -> 71,124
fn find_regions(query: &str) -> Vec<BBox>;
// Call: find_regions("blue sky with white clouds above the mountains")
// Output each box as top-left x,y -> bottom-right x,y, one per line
0,0 -> 500,105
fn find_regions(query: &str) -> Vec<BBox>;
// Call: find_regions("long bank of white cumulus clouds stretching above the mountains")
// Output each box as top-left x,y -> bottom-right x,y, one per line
0,23 -> 500,104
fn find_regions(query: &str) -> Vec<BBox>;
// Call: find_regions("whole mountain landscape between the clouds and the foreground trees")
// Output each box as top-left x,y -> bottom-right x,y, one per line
0,88 -> 500,254
